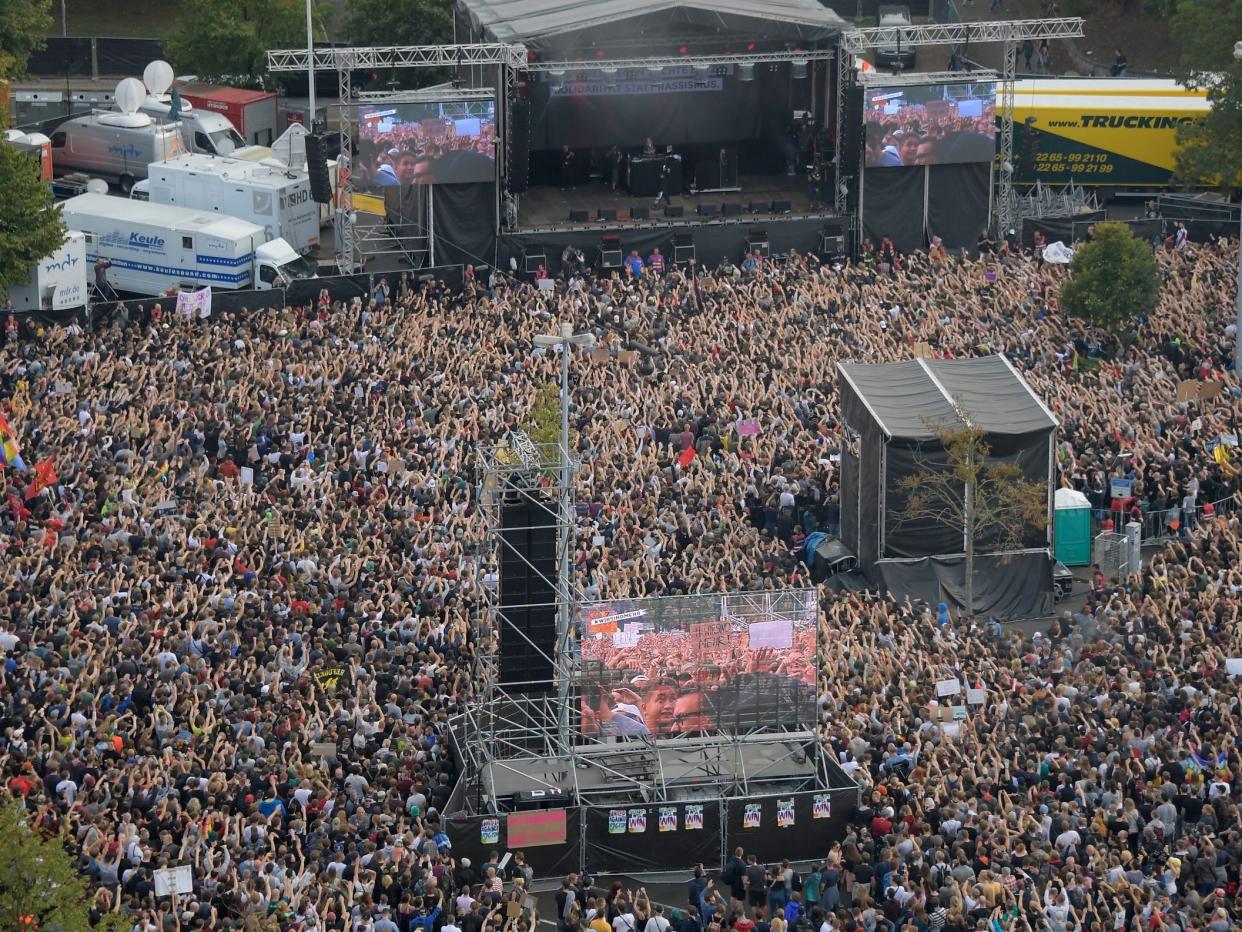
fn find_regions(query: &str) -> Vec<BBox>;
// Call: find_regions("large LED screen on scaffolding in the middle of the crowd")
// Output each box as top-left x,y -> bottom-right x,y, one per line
578,589 -> 817,737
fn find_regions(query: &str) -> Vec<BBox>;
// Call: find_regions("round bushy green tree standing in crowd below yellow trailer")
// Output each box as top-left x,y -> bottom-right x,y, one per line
1061,224 -> 1160,331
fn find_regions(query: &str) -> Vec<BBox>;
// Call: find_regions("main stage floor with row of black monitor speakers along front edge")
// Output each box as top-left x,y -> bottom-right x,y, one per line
517,175 -> 831,234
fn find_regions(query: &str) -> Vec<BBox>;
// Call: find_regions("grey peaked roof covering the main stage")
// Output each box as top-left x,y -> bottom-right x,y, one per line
457,0 -> 846,51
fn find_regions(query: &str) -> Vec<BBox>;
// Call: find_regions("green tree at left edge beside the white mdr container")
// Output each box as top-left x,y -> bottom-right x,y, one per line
0,143 -> 65,304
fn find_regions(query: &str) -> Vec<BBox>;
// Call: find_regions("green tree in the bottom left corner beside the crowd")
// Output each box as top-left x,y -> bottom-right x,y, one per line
0,798 -> 133,932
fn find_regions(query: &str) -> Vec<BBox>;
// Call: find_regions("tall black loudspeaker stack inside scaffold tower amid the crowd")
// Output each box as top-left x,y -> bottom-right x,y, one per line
498,492 -> 556,692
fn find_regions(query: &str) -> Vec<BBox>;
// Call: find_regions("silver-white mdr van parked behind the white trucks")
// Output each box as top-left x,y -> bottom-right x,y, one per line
52,112 -> 184,194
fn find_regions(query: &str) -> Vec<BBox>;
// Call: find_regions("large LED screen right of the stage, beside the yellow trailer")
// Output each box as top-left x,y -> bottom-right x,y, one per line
863,82 -> 996,168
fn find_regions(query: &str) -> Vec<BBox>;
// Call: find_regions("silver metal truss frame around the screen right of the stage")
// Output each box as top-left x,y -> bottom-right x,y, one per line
836,16 -> 1083,232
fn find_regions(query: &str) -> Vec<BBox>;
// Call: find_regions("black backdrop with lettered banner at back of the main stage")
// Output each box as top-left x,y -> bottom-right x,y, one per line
530,67 -> 765,149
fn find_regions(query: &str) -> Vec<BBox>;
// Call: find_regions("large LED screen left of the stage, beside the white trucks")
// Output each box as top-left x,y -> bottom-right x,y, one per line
354,101 -> 496,188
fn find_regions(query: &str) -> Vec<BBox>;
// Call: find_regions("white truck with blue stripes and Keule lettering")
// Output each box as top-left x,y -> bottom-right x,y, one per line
62,194 -> 315,295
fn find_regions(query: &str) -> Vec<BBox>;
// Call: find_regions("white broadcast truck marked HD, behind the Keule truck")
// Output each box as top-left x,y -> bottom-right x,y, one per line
129,155 -> 319,255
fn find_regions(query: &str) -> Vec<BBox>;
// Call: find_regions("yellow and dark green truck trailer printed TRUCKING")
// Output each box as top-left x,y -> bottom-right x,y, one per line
996,78 -> 1210,188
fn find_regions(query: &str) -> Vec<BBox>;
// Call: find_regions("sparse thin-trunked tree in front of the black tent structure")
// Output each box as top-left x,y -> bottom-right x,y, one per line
897,420 -> 1048,610
